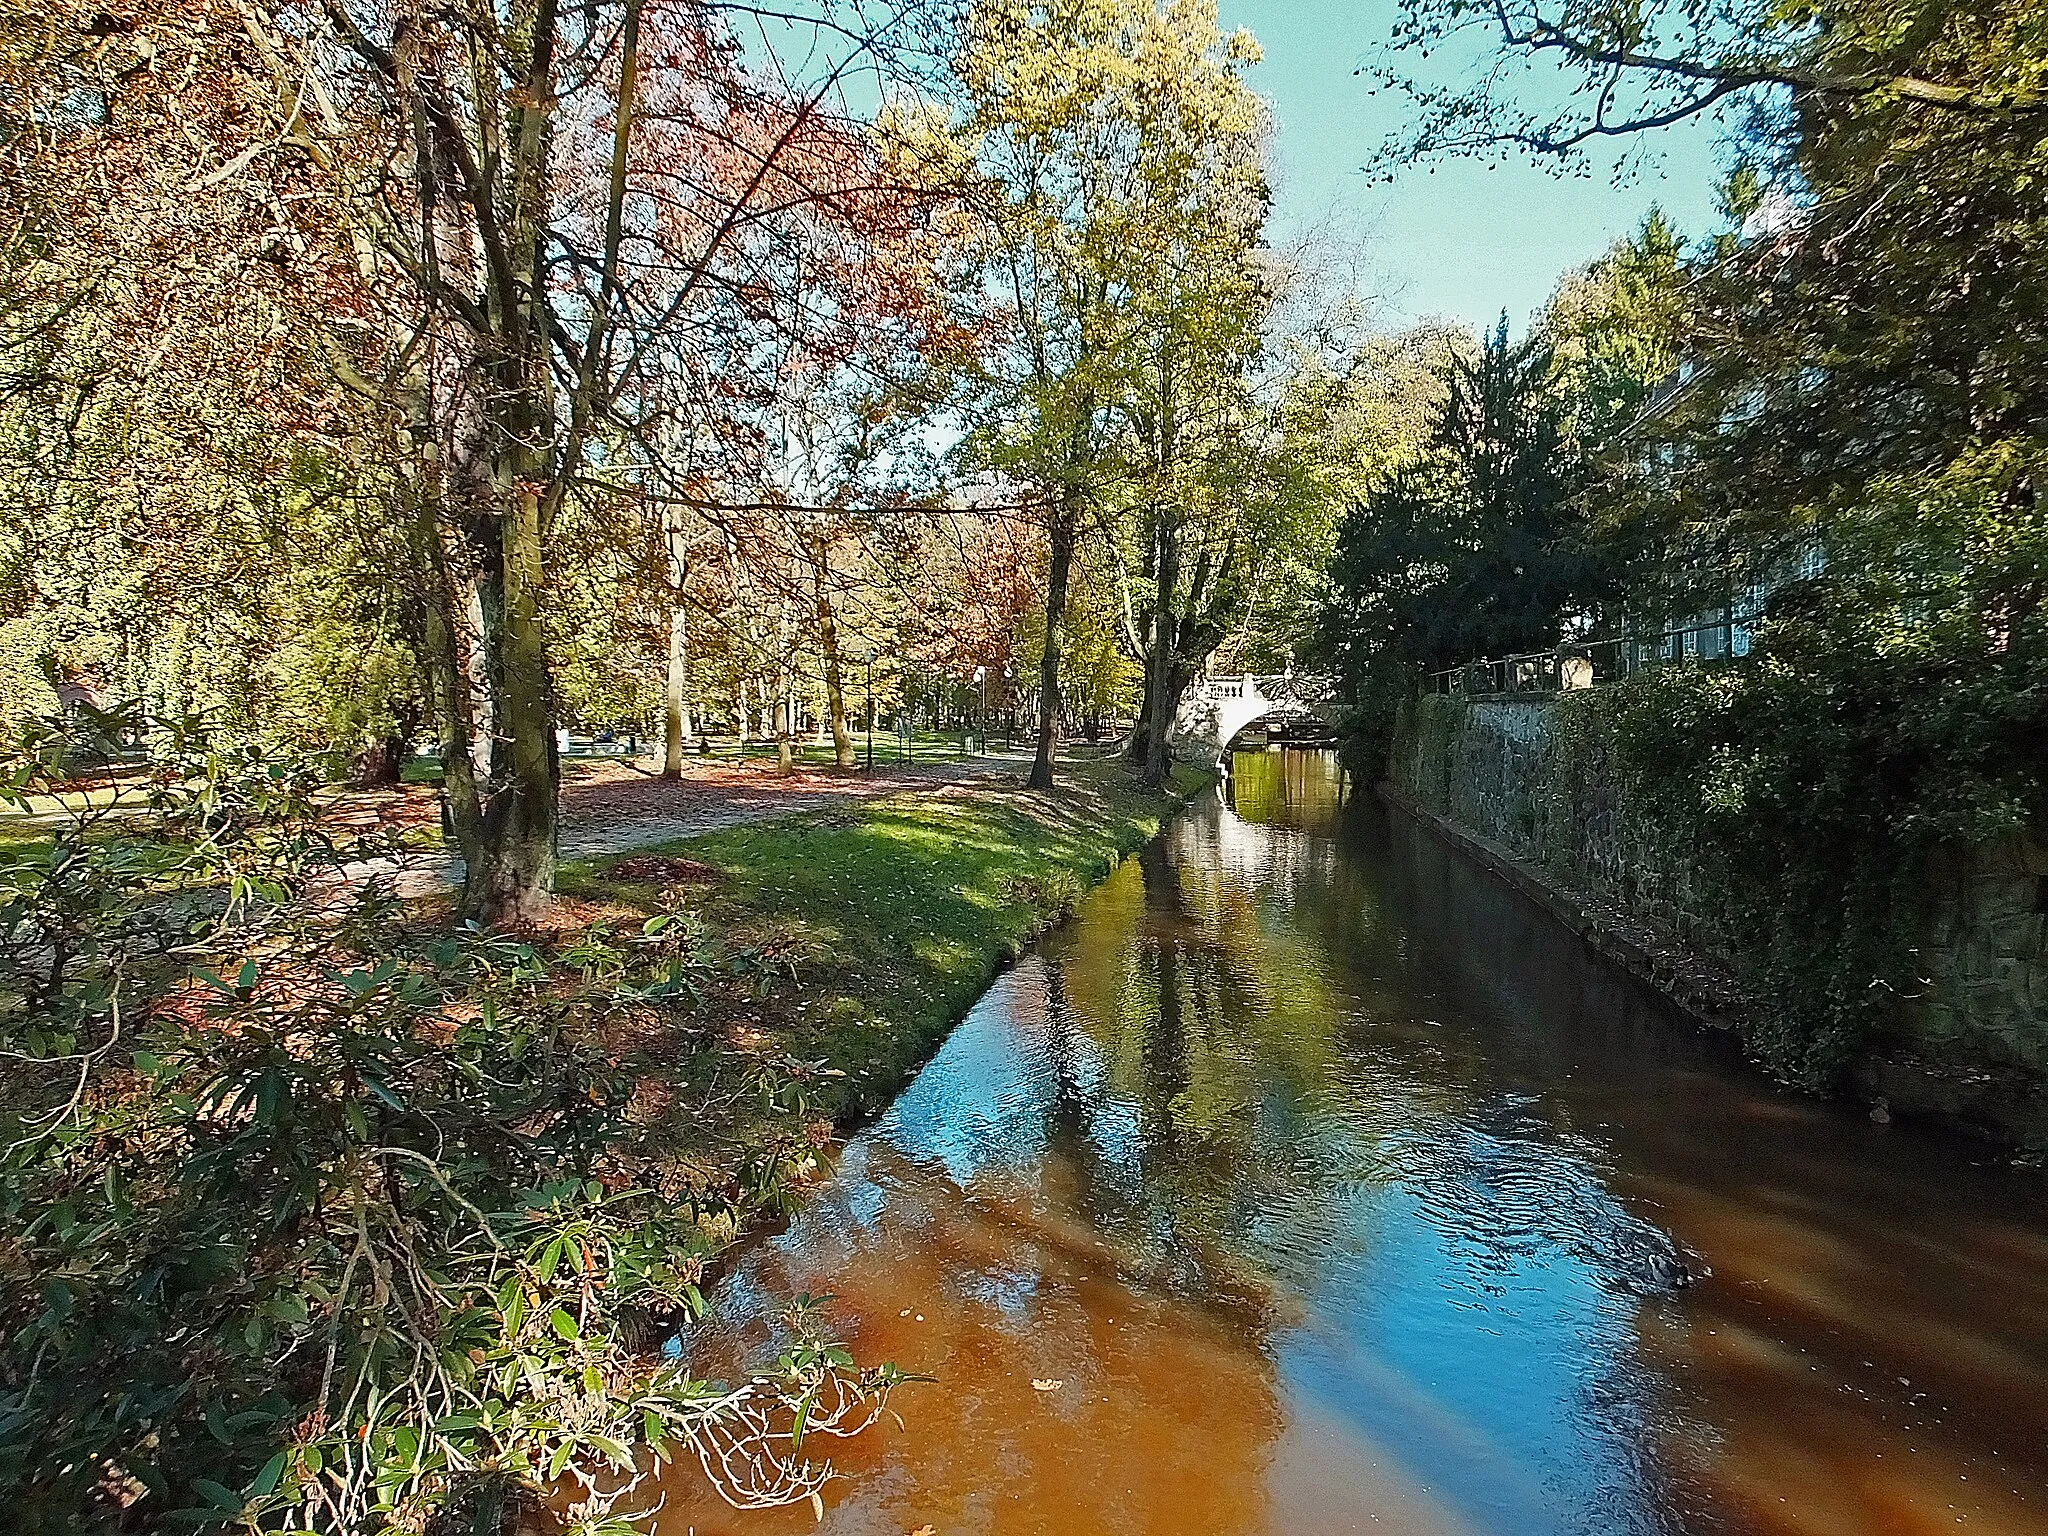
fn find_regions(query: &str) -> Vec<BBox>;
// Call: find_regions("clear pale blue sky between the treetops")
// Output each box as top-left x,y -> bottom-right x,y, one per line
1221,0 -> 1716,330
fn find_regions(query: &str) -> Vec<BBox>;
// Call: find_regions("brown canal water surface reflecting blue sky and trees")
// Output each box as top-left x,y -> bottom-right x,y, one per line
662,754 -> 2048,1536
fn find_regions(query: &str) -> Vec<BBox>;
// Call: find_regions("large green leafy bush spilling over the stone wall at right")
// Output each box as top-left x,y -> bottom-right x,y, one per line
1597,453 -> 2048,1085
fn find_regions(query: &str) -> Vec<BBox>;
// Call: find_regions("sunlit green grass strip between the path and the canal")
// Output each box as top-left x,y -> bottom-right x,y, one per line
561,762 -> 1208,1124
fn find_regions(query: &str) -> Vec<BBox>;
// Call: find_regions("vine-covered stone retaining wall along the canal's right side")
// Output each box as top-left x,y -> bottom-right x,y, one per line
1380,694 -> 2048,1161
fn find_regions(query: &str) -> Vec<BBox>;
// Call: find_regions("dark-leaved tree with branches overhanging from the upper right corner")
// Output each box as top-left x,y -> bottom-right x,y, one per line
1389,0 -> 2048,586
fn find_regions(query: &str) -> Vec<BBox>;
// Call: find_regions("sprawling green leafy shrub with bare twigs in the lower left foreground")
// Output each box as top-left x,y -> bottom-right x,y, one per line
0,727 -> 893,1532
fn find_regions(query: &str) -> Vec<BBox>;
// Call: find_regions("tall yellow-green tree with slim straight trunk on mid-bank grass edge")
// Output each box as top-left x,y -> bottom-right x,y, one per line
954,0 -> 1266,786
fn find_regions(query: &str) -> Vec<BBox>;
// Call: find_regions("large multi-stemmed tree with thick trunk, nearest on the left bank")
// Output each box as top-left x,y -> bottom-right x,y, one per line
205,0 -> 942,920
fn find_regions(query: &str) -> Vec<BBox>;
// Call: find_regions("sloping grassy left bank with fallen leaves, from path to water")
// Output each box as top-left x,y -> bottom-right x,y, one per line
561,762 -> 1212,1153
